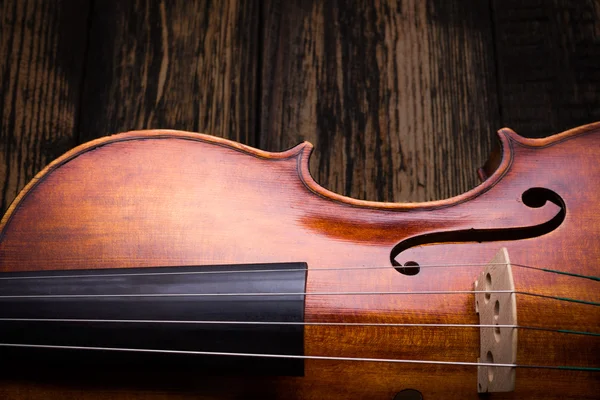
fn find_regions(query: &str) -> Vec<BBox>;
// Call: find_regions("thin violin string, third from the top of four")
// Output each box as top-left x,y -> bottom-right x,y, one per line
0,318 -> 600,336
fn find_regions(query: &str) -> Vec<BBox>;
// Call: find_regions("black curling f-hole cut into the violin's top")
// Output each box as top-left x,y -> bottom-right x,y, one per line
390,187 -> 566,276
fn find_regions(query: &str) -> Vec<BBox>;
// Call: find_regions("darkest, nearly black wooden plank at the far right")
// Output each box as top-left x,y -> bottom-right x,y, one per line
493,0 -> 600,137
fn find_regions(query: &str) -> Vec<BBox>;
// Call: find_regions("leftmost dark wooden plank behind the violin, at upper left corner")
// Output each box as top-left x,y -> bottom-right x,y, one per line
0,0 -> 89,214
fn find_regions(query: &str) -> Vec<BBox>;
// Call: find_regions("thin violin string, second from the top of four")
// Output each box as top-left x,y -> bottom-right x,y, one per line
0,290 -> 600,306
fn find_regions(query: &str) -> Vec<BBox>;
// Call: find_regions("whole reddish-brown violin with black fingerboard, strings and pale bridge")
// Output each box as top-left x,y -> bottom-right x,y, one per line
0,123 -> 600,400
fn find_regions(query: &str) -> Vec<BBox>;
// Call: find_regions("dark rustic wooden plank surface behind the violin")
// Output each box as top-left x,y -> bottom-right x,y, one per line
0,0 -> 600,216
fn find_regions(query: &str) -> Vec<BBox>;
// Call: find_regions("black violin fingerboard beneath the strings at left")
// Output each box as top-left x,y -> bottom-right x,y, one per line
0,263 -> 306,375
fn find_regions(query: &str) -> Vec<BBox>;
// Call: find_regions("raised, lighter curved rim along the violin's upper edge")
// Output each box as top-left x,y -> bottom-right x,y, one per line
0,121 -> 600,232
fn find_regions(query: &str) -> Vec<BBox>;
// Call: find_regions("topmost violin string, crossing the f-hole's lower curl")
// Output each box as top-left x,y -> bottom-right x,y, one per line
0,263 -> 600,282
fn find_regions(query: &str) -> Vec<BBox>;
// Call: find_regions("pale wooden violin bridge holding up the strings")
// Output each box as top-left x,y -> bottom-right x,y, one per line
475,247 -> 517,393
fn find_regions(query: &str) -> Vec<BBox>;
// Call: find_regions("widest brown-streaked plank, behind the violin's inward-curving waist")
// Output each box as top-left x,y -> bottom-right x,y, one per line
260,0 -> 500,201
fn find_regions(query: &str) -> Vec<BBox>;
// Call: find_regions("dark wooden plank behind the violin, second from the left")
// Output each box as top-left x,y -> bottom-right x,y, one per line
81,0 -> 259,144
